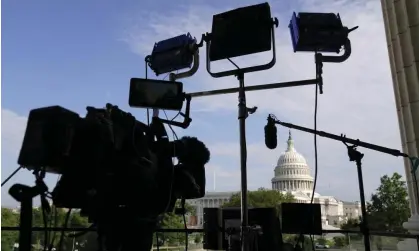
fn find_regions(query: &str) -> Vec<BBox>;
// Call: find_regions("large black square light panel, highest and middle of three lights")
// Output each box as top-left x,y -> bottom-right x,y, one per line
209,3 -> 272,61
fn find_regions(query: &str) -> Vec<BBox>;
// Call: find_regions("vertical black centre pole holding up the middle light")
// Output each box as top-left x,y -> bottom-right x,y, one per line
237,73 -> 249,251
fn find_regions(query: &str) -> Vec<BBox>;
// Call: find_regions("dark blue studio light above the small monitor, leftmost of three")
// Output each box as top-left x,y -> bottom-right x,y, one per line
148,33 -> 196,76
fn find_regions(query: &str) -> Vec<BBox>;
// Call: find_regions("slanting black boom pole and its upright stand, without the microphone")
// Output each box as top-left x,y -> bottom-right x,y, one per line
268,114 -> 409,251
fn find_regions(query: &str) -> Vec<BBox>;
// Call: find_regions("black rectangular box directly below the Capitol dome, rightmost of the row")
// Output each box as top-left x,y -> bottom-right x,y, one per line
281,203 -> 322,235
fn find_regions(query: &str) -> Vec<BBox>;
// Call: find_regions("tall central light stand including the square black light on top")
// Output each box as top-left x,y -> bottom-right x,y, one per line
203,3 -> 278,251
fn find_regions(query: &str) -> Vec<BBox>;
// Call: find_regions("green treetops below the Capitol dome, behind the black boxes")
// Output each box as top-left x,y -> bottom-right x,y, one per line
223,188 -> 294,213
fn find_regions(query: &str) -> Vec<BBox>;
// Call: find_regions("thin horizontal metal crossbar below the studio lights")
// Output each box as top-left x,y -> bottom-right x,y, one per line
188,79 -> 318,98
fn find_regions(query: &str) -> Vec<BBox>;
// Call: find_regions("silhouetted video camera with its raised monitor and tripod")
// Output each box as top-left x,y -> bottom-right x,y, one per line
9,78 -> 210,251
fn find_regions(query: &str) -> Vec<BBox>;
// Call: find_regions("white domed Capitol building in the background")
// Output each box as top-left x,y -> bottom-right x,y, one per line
188,132 -> 361,229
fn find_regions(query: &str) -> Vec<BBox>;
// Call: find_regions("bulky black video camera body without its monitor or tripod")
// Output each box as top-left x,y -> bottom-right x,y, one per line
18,104 -> 210,221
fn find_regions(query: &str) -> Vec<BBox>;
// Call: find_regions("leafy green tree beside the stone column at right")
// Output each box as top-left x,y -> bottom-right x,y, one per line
367,173 -> 410,232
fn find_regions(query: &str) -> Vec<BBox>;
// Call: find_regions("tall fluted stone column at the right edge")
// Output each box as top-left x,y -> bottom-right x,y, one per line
381,0 -> 419,250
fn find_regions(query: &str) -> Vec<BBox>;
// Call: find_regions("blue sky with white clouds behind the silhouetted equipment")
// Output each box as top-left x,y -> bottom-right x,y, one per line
1,0 -> 404,206
